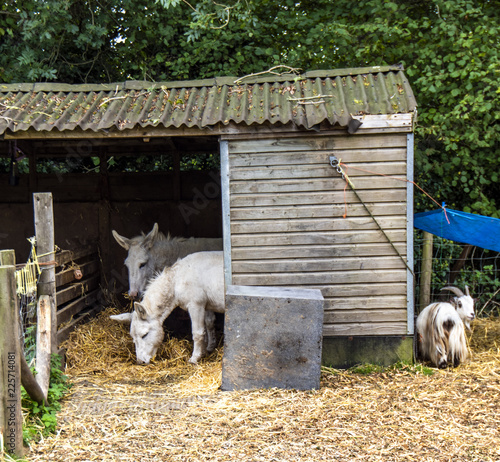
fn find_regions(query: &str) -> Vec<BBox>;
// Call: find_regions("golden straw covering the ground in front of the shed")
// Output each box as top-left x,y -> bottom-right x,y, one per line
28,310 -> 500,462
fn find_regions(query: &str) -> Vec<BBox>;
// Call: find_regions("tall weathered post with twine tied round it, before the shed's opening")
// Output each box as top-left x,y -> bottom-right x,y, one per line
33,193 -> 57,354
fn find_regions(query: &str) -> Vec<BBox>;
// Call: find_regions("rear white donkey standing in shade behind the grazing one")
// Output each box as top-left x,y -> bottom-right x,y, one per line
112,223 -> 222,299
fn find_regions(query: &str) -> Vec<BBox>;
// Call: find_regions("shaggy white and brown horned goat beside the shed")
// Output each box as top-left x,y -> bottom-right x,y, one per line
417,286 -> 474,368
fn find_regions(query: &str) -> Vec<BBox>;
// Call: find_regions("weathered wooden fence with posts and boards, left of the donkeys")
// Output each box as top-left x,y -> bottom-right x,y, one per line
0,193 -> 101,456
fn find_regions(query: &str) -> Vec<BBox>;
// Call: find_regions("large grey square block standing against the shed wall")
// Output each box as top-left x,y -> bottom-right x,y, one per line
222,286 -> 323,390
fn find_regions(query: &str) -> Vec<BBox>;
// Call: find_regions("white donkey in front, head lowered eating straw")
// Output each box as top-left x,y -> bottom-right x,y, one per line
110,252 -> 225,364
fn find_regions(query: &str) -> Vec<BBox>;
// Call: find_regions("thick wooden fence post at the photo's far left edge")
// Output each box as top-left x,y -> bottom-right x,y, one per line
0,258 -> 23,457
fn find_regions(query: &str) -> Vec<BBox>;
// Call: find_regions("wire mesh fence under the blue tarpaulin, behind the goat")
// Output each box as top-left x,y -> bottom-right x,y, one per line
414,230 -> 500,317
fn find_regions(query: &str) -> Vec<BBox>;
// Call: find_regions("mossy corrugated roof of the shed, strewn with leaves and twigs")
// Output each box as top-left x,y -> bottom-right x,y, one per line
0,66 -> 416,134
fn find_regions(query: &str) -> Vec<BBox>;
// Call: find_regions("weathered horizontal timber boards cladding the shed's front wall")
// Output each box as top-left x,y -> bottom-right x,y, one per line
228,134 -> 407,336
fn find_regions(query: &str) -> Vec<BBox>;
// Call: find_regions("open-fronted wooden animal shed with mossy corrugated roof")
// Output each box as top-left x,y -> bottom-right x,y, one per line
0,66 -> 416,366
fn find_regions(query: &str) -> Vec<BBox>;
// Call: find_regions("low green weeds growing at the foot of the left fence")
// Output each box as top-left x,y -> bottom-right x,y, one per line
21,355 -> 71,443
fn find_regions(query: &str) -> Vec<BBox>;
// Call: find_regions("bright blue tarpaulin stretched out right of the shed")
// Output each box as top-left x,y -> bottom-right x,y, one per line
413,208 -> 500,252
